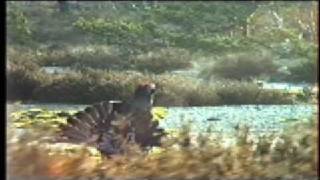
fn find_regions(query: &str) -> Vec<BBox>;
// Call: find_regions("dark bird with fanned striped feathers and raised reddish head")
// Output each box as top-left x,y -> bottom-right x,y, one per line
59,83 -> 165,156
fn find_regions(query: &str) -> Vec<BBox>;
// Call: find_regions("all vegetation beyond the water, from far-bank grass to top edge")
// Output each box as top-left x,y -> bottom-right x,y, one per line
7,1 -> 318,105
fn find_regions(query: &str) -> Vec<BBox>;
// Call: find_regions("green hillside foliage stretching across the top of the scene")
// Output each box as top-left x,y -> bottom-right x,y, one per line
8,1 -> 316,57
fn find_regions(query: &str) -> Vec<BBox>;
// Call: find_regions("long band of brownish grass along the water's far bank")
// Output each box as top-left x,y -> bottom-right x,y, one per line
8,64 -> 292,106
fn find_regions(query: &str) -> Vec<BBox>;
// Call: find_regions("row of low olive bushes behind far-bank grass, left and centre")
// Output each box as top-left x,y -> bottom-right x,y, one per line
24,46 -> 192,74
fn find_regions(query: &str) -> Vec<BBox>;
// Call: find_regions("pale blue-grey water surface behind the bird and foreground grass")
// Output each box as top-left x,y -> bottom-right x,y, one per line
9,104 -> 317,133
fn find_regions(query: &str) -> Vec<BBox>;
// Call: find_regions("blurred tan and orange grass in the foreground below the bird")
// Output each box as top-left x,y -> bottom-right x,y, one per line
7,107 -> 318,179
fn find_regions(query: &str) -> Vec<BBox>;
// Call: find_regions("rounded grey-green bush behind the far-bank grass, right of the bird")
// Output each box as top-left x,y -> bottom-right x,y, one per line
201,53 -> 277,80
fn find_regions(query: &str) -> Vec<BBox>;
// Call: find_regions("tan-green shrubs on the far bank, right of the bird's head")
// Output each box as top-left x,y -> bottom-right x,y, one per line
155,75 -> 293,106
